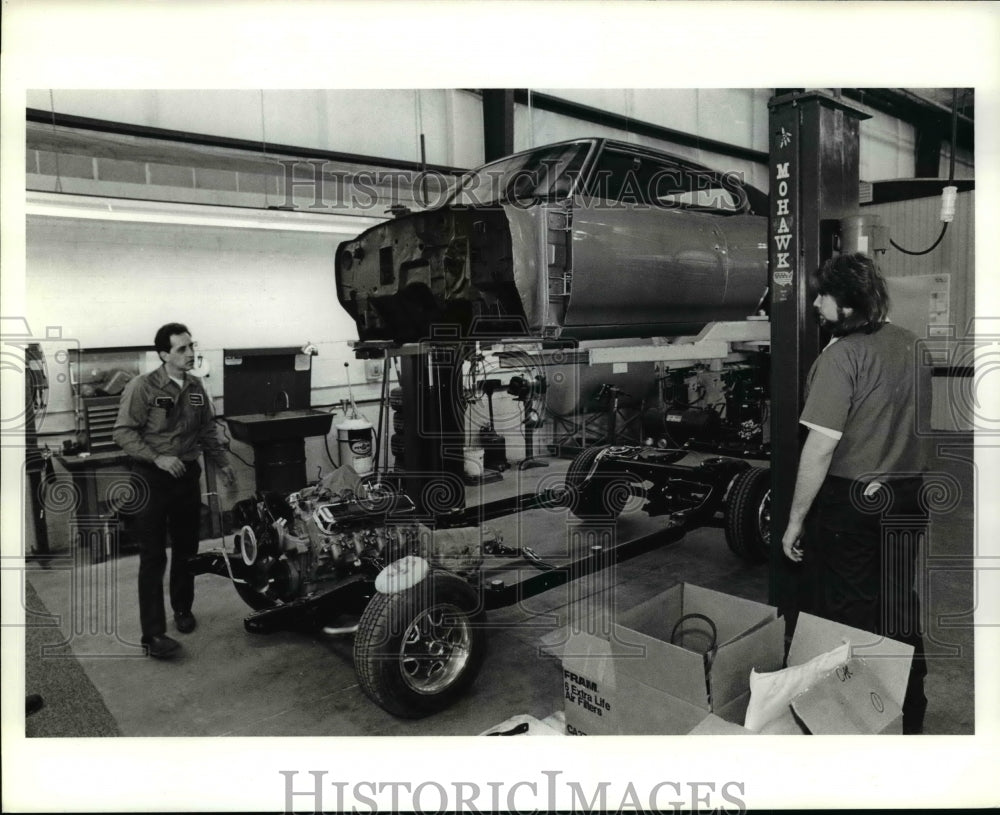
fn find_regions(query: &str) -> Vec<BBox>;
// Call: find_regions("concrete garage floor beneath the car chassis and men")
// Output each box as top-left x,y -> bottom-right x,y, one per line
25,446 -> 975,737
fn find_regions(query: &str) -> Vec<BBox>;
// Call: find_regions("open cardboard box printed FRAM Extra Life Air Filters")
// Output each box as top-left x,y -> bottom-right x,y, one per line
562,584 -> 784,735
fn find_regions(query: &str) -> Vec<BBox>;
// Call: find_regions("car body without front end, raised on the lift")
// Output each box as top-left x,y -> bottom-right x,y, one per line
335,138 -> 767,342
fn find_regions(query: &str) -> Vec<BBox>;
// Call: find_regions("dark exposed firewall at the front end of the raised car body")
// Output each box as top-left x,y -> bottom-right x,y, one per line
336,207 -> 524,342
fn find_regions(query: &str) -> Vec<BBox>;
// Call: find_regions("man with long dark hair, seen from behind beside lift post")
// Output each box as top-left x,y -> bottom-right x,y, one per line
782,254 -> 931,733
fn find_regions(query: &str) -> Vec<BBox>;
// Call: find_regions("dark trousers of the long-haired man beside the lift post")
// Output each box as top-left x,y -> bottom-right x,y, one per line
803,476 -> 928,733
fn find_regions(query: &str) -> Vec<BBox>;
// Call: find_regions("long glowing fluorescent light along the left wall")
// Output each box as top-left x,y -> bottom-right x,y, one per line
26,191 -> 386,238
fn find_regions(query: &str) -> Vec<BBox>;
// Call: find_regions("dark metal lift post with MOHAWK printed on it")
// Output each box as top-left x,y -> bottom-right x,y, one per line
768,92 -> 870,619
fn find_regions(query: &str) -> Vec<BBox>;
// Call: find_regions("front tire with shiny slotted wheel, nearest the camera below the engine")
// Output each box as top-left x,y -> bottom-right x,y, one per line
354,572 -> 486,719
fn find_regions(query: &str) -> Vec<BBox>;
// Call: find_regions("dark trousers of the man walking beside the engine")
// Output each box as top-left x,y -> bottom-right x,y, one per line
132,461 -> 201,637
